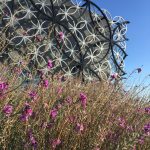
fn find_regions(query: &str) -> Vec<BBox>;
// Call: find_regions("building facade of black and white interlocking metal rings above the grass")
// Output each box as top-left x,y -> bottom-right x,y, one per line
0,0 -> 128,80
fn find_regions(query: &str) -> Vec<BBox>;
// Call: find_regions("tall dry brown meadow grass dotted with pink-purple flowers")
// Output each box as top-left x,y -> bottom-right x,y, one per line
0,61 -> 150,150
